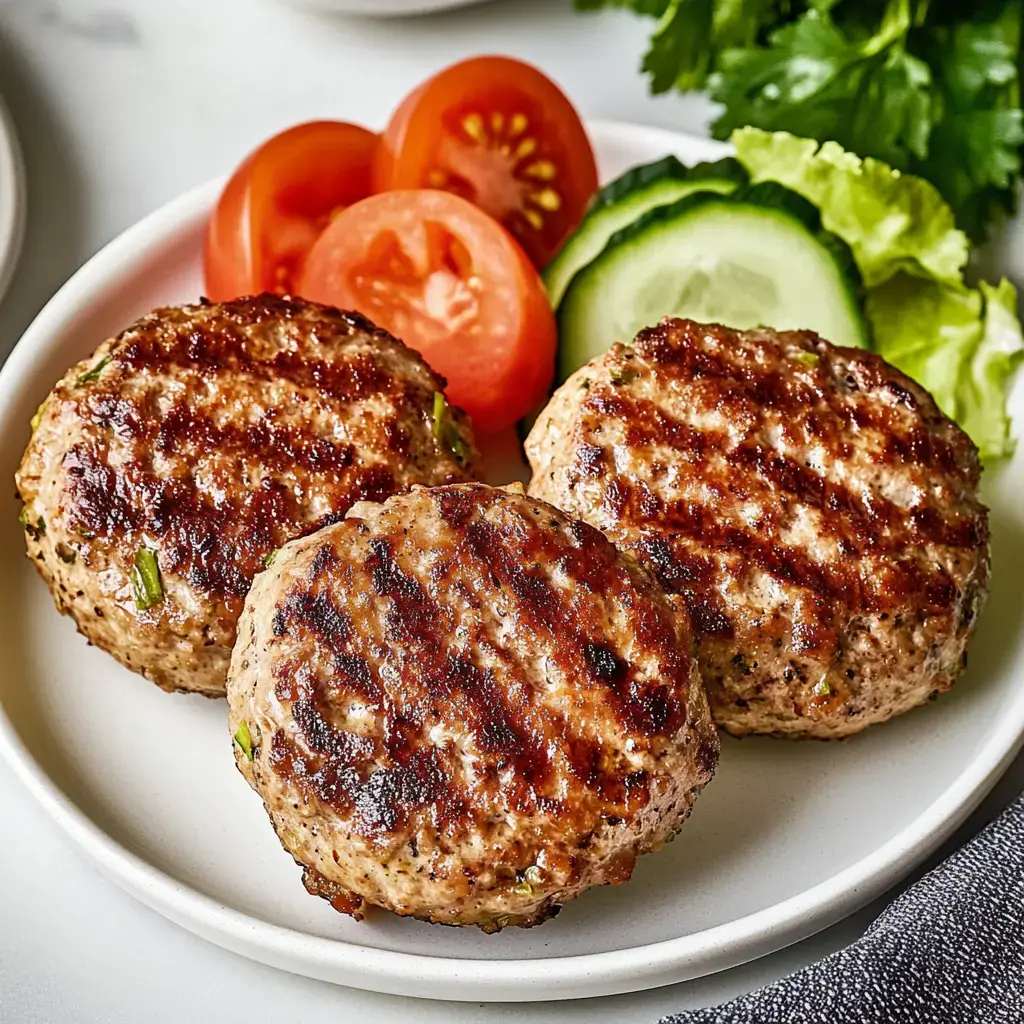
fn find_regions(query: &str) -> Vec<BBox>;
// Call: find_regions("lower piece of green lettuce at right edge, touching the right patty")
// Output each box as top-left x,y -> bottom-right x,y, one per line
864,273 -> 1024,462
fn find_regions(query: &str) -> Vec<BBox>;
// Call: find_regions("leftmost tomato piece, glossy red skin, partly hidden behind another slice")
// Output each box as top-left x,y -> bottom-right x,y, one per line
204,121 -> 379,301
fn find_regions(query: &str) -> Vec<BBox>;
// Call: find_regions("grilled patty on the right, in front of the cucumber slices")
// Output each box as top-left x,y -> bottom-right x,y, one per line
526,319 -> 989,738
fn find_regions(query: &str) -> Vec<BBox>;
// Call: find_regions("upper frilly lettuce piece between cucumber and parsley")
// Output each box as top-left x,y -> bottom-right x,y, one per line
731,128 -> 969,288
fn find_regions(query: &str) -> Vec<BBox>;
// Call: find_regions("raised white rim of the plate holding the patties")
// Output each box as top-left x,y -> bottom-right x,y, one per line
0,121 -> 1024,1001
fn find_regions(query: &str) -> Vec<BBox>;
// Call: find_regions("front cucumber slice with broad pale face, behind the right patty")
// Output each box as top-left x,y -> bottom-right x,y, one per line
558,182 -> 867,381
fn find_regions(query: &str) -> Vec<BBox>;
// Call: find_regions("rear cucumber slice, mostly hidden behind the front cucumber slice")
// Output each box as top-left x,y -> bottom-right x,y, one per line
544,157 -> 750,309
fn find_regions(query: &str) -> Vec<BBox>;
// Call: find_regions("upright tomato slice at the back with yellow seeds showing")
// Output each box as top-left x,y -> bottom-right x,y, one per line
374,56 -> 597,267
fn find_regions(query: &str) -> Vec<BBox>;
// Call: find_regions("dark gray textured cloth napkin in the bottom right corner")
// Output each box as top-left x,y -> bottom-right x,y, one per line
663,798 -> 1024,1024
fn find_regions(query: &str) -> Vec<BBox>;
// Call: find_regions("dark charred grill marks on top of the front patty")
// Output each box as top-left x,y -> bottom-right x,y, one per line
271,487 -> 689,836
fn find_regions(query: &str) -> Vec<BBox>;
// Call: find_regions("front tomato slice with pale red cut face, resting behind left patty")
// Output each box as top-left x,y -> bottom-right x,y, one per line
300,189 -> 556,433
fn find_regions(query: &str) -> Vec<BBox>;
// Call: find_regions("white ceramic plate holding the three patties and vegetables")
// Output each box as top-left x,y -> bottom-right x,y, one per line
0,124 -> 1024,1000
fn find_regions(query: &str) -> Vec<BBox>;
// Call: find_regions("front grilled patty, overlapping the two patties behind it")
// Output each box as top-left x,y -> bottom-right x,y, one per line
228,484 -> 718,931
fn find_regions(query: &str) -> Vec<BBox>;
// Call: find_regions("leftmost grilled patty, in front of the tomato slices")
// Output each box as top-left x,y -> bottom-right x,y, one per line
16,295 -> 476,696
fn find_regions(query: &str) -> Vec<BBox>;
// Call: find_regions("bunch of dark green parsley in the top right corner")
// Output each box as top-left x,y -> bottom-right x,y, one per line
577,0 -> 1024,239
